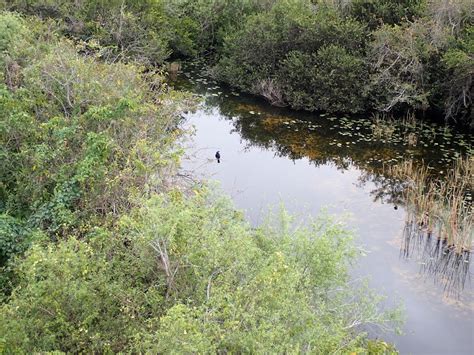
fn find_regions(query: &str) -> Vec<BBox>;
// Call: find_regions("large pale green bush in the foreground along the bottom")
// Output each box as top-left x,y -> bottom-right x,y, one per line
0,191 -> 402,353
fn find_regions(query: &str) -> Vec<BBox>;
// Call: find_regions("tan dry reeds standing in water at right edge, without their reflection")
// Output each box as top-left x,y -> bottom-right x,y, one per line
387,157 -> 474,252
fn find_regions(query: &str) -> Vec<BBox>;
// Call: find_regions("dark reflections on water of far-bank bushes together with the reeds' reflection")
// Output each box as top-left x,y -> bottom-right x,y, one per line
174,68 -> 472,296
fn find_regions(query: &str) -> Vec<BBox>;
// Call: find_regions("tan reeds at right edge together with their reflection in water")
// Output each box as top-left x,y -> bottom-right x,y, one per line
387,157 -> 474,296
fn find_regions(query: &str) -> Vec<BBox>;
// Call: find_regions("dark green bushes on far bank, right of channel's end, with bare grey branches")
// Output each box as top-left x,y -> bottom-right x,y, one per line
215,1 -> 474,125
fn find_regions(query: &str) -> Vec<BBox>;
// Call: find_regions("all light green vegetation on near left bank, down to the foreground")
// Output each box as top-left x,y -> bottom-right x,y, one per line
0,6 -> 401,353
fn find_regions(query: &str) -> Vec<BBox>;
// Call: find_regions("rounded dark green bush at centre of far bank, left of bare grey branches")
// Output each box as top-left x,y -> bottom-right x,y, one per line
216,1 -> 367,112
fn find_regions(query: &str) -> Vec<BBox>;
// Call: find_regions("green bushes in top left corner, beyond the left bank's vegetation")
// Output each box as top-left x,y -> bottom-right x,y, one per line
2,0 -> 171,65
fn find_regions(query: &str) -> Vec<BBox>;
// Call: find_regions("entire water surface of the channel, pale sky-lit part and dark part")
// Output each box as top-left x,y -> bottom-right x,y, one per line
172,69 -> 474,354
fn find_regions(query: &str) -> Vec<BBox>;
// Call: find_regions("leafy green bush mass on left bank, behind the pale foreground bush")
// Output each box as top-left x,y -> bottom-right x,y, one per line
0,21 -> 190,238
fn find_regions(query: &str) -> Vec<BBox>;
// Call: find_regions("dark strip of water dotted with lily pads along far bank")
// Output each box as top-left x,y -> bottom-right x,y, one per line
172,64 -> 473,173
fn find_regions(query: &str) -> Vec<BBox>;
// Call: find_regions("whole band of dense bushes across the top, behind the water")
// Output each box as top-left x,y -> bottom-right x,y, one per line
3,0 -> 474,126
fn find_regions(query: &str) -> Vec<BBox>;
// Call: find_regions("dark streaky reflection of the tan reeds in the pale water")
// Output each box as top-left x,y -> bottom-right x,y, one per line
400,220 -> 471,297
